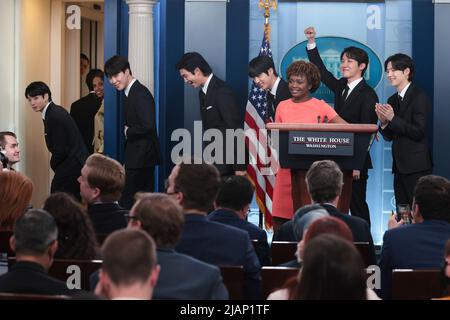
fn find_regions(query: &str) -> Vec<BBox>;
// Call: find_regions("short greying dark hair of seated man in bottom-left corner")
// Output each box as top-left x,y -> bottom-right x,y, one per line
14,209 -> 58,255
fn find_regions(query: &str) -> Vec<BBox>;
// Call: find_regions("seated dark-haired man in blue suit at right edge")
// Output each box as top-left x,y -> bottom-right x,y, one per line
380,175 -> 450,299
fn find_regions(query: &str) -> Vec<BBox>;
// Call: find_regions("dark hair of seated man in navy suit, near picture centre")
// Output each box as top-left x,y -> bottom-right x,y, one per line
174,163 -> 220,212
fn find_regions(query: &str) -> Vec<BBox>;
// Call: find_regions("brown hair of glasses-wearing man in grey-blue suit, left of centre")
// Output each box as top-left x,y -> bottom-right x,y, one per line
133,193 -> 184,248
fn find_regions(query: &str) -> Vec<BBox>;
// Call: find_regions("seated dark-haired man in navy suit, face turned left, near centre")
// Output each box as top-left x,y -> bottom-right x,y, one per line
167,162 -> 261,299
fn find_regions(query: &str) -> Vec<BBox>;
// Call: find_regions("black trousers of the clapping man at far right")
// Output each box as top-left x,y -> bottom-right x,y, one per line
394,170 -> 431,209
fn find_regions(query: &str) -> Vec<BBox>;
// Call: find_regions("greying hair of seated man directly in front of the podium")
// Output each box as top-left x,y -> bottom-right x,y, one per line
305,160 -> 344,203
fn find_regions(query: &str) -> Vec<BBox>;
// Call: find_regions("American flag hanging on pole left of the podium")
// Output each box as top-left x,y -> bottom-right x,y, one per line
244,31 -> 275,228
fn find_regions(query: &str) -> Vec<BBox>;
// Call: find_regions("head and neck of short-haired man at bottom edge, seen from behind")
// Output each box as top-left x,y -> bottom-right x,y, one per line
95,230 -> 159,300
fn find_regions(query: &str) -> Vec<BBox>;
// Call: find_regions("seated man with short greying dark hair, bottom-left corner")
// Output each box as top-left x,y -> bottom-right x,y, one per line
0,209 -> 75,295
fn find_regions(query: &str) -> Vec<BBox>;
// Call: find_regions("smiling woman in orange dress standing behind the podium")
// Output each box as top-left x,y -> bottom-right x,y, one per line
272,61 -> 347,231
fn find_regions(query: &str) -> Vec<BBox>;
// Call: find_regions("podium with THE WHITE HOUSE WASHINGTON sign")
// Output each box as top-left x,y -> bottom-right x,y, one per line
266,122 -> 378,213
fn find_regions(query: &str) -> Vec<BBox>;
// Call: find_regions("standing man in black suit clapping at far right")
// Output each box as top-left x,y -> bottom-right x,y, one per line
375,53 -> 433,206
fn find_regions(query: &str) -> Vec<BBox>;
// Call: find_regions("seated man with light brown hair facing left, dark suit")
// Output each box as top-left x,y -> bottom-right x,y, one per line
78,154 -> 128,233
